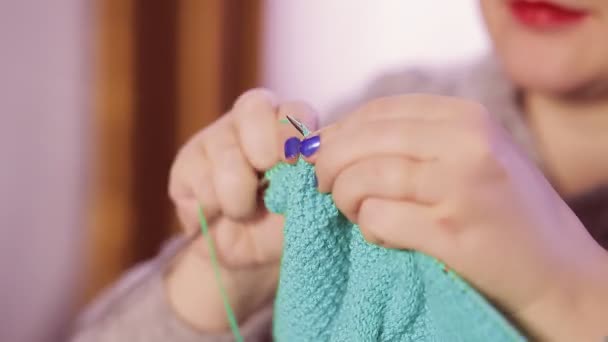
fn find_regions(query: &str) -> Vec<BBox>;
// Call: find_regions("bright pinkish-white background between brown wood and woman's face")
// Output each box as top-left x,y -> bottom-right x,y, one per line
261,0 -> 488,113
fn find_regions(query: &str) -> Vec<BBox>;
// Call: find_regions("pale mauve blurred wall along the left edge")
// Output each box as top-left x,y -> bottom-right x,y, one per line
0,0 -> 93,342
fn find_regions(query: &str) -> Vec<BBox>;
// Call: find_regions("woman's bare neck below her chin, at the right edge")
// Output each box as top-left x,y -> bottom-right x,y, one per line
523,93 -> 608,195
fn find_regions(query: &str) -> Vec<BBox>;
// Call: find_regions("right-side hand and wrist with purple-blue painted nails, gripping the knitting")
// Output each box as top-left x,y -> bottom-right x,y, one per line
302,95 -> 608,340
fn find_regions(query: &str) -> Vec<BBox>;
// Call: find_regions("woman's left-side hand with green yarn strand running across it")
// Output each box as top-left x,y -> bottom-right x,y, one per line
166,90 -> 316,332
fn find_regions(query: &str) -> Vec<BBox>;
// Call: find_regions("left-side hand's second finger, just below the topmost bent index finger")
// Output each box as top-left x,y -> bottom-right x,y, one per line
205,125 -> 259,219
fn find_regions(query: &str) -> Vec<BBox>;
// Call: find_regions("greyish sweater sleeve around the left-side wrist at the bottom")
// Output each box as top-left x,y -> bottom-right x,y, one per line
70,239 -> 272,342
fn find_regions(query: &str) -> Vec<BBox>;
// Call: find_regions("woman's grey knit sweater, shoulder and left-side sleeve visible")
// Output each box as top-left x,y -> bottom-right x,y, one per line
72,57 -> 608,342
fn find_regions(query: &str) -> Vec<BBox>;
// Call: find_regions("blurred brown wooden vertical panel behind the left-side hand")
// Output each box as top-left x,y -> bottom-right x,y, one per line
85,0 -> 262,300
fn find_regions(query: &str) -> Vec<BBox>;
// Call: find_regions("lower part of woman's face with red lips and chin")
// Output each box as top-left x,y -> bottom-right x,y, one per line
480,0 -> 608,98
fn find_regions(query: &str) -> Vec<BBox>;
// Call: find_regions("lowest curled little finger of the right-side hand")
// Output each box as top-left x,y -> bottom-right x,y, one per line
358,198 -> 445,251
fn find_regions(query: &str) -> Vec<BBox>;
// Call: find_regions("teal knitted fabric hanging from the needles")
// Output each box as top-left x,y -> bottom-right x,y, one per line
265,160 -> 525,342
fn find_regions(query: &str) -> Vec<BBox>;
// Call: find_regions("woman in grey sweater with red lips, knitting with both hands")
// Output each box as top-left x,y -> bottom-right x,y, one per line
74,0 -> 608,341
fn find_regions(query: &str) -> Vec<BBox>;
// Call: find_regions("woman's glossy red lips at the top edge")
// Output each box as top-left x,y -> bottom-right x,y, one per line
511,0 -> 588,29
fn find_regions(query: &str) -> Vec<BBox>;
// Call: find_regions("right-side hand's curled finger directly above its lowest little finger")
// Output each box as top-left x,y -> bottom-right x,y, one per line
331,156 -> 444,223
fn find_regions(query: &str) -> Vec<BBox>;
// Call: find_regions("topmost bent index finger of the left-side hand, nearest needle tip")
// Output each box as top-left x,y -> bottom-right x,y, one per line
231,89 -> 283,171
